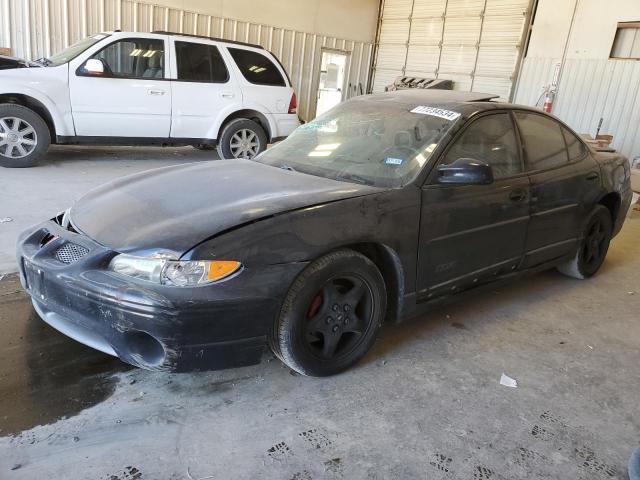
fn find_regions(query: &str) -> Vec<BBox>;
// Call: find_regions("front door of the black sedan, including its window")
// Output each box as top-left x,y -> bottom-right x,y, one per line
418,112 -> 530,301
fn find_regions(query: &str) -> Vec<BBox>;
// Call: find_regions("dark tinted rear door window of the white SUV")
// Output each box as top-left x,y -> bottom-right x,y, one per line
175,42 -> 229,83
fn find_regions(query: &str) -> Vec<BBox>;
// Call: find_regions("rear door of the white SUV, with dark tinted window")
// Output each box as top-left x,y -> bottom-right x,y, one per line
171,38 -> 242,140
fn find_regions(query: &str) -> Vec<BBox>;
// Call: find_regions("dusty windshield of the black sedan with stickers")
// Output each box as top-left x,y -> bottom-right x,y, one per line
255,97 -> 459,188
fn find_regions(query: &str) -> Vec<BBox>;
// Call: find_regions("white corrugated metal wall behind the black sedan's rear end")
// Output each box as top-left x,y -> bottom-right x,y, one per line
515,58 -> 640,159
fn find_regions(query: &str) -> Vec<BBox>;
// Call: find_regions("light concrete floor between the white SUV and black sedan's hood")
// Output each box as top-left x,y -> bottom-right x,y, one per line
0,145 -> 218,275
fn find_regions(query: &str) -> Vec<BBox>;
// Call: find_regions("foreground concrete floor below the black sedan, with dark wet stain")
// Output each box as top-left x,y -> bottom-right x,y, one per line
0,212 -> 640,480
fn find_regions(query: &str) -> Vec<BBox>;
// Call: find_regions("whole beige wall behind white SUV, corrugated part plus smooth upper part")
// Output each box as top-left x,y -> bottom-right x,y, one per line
0,0 -> 378,120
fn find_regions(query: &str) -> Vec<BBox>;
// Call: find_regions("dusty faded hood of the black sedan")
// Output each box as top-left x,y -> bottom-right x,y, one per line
70,160 -> 381,256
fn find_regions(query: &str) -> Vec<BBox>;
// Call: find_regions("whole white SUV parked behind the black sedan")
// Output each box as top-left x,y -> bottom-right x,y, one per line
0,32 -> 299,167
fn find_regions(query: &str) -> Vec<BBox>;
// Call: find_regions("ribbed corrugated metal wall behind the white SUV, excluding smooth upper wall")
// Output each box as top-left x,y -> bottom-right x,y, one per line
0,0 -> 372,120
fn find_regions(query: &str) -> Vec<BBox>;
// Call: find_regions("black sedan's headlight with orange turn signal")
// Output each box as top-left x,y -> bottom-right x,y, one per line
109,253 -> 242,287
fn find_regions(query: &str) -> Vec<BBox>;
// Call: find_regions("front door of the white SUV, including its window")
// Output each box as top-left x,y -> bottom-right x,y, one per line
69,34 -> 171,138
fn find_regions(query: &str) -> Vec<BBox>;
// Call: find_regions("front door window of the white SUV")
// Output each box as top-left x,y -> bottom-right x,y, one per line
91,38 -> 164,78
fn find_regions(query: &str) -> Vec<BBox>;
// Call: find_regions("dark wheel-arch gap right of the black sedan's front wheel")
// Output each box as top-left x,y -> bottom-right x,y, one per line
344,242 -> 404,323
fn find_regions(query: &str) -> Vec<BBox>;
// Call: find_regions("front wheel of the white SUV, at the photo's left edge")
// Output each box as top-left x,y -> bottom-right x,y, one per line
0,104 -> 51,168
